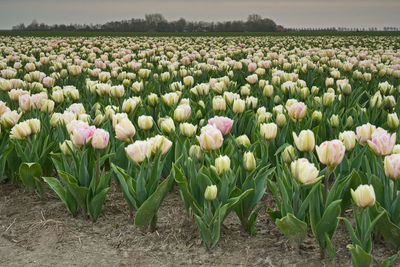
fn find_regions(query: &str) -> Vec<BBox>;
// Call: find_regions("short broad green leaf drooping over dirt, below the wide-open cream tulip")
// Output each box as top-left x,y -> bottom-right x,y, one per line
275,213 -> 307,246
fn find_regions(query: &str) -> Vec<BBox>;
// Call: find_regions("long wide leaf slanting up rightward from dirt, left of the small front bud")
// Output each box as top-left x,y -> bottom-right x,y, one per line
135,175 -> 174,227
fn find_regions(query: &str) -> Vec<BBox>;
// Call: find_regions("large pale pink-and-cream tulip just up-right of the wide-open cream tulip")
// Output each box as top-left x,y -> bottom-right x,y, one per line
315,140 -> 346,167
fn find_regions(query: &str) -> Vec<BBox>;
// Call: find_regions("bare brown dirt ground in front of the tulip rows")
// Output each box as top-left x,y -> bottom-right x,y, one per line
0,184 -> 400,267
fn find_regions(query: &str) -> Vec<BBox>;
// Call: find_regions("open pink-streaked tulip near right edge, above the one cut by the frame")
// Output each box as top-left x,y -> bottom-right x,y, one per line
367,128 -> 396,156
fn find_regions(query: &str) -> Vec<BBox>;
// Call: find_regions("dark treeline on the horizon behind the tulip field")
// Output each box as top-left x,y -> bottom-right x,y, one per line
12,14 -> 283,32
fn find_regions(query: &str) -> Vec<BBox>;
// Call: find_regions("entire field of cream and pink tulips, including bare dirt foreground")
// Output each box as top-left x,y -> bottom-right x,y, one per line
0,36 -> 400,266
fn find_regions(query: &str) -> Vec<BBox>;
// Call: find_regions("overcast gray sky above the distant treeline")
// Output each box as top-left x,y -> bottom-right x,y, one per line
0,0 -> 400,29
